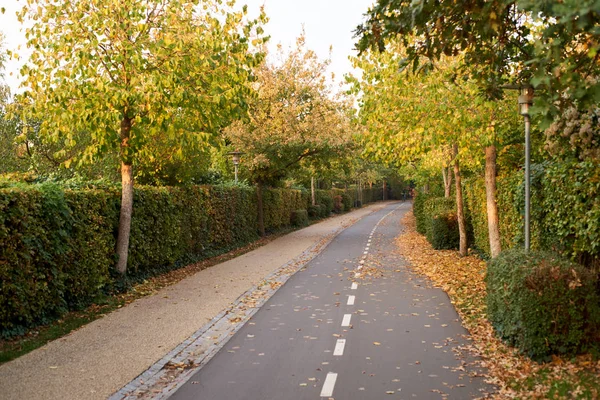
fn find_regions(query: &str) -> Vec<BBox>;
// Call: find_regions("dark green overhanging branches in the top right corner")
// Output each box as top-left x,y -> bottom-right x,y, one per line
356,0 -> 600,126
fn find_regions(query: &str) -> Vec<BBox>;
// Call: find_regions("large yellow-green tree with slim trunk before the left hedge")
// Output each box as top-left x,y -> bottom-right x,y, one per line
20,0 -> 264,273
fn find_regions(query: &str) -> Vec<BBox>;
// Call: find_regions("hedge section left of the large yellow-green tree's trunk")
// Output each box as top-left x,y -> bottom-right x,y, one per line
0,184 -> 118,337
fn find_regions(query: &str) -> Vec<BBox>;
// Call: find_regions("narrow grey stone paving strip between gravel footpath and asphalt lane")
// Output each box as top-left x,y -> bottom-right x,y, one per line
109,205 -> 390,400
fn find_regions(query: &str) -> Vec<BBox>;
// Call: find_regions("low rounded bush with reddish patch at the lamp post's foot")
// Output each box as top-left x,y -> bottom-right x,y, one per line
486,249 -> 600,359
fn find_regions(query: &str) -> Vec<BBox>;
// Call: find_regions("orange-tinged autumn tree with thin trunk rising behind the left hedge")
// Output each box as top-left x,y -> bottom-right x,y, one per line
226,36 -> 351,234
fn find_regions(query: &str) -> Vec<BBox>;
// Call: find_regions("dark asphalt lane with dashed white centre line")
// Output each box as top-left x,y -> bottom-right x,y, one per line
170,203 -> 493,400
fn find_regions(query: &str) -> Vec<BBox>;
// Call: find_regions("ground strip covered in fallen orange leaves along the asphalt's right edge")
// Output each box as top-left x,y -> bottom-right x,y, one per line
397,213 -> 600,399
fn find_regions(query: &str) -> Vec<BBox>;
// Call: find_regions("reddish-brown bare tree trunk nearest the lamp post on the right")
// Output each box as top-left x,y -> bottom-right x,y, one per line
485,145 -> 502,258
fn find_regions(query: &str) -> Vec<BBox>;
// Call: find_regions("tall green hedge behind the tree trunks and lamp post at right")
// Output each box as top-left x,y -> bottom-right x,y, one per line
462,161 -> 600,266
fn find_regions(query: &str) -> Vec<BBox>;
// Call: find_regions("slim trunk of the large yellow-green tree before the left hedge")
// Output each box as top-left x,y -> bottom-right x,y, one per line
116,118 -> 133,275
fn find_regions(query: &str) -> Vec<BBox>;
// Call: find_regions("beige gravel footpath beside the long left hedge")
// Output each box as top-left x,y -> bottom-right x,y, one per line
0,202 -> 388,400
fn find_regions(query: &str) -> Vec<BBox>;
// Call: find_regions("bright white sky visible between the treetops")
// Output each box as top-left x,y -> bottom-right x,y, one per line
0,0 -> 373,93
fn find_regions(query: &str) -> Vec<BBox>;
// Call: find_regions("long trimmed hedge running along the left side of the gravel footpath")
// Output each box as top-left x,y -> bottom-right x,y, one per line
0,182 -> 384,337
